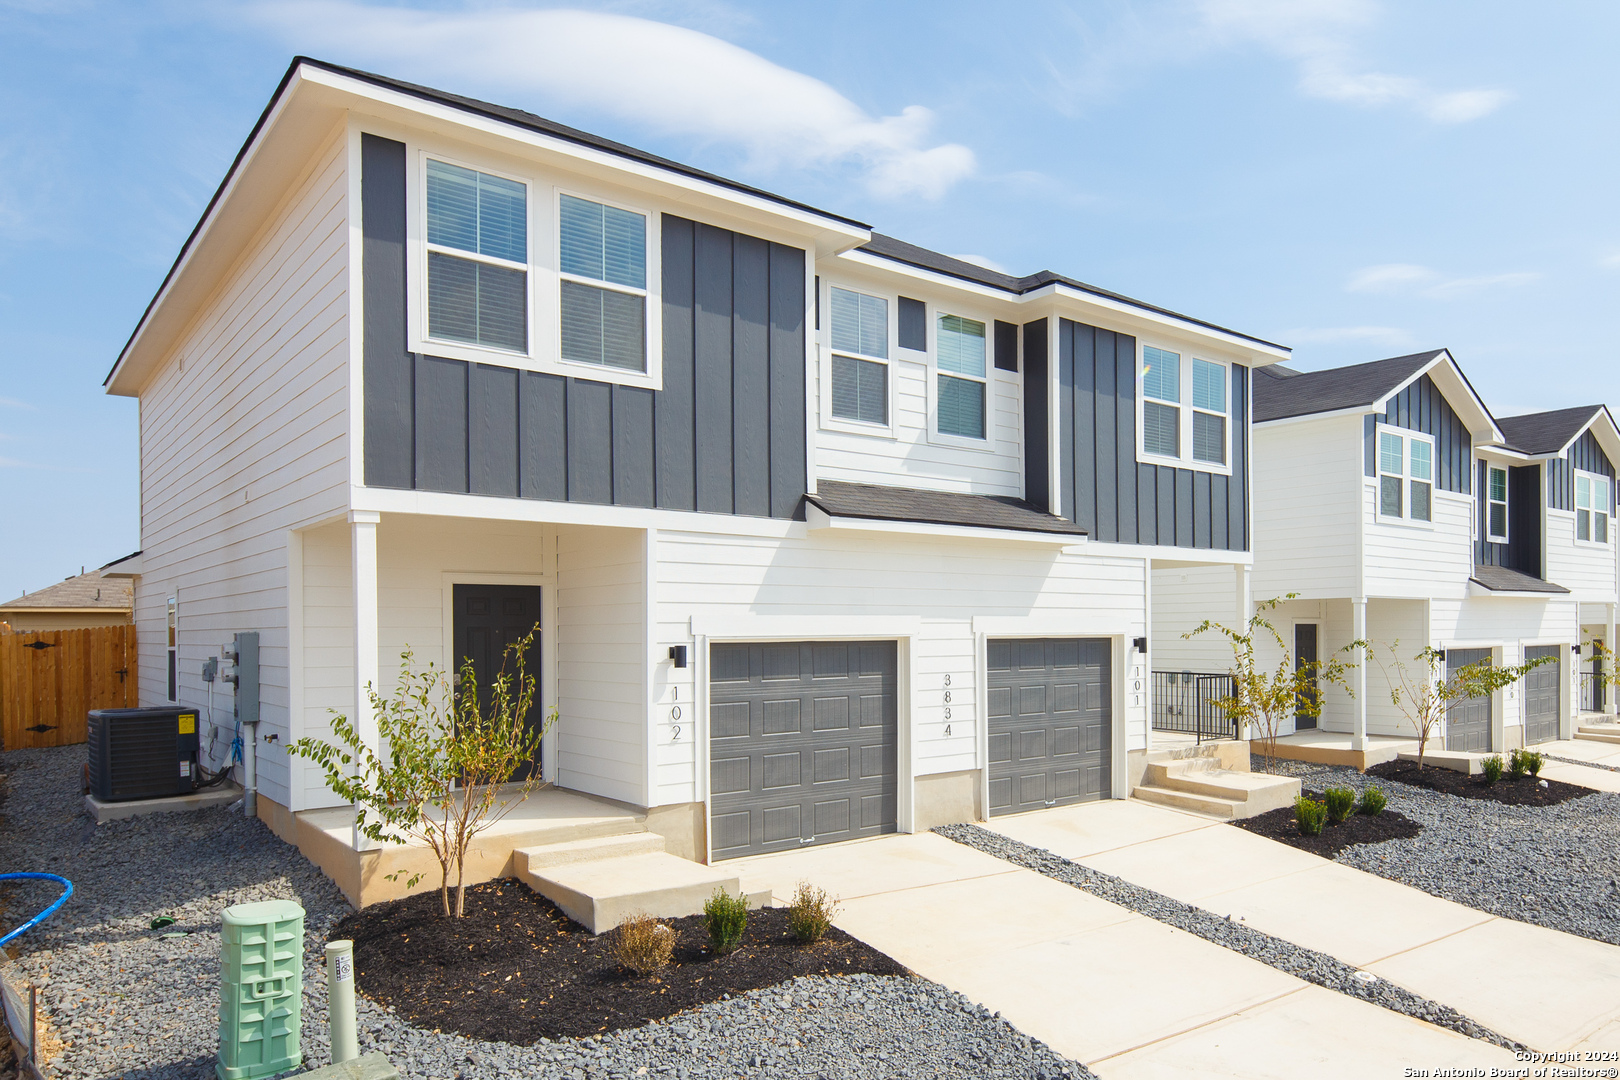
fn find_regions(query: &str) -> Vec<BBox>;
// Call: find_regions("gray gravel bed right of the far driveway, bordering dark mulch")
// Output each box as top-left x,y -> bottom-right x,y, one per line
1256,761 -> 1620,946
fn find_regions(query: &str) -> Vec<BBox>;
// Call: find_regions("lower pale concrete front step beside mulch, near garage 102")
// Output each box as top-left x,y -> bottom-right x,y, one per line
518,852 -> 740,934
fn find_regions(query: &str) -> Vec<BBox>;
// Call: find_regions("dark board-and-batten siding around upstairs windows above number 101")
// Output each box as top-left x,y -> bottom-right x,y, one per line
1049,319 -> 1249,551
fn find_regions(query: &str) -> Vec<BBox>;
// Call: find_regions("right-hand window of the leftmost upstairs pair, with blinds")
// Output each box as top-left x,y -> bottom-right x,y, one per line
557,194 -> 646,372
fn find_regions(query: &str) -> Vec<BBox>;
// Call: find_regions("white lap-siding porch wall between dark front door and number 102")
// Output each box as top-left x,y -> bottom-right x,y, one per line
556,528 -> 648,806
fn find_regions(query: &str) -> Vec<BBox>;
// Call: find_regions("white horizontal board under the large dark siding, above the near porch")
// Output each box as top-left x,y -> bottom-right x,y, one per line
348,487 -> 805,539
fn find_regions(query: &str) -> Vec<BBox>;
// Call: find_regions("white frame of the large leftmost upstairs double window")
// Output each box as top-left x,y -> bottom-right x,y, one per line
405,142 -> 664,390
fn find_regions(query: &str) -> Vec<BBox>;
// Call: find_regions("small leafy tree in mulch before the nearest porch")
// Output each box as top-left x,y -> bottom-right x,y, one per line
287,633 -> 557,918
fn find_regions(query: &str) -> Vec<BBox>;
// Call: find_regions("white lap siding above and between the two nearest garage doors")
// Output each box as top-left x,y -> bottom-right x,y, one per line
654,531 -> 1145,801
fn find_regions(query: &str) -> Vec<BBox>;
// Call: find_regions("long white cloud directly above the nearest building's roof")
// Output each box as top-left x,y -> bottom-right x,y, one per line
248,0 -> 977,199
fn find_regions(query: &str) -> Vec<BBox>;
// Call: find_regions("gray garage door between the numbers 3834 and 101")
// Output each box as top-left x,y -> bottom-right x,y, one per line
987,638 -> 1113,814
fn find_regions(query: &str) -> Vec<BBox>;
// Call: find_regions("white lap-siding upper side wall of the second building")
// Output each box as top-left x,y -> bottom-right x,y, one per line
1251,416 -> 1362,599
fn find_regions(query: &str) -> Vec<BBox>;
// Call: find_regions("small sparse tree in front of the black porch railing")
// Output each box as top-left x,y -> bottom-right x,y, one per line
1181,593 -> 1362,772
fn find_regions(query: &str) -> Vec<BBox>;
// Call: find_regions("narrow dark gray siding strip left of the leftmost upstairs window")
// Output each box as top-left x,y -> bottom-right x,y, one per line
360,134 -> 415,487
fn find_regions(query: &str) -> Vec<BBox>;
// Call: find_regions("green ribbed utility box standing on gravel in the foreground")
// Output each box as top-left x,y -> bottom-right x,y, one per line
214,900 -> 303,1080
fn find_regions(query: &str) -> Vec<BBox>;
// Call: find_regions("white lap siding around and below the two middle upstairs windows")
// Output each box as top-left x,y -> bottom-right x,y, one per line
812,361 -> 1024,497
